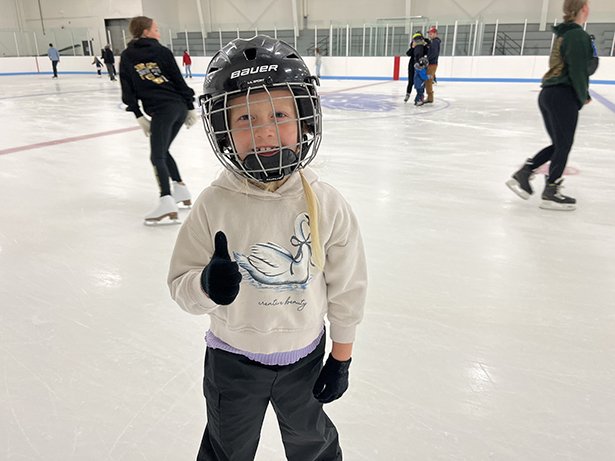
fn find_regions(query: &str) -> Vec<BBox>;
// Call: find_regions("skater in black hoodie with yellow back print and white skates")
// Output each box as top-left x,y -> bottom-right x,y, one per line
120,16 -> 198,224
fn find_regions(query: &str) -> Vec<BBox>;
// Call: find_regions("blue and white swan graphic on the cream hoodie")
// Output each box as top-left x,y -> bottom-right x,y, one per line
233,213 -> 312,291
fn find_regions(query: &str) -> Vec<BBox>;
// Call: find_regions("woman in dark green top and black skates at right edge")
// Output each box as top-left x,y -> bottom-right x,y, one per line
506,0 -> 598,210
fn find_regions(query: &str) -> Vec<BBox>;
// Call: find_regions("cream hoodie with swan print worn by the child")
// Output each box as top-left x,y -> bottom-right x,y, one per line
168,169 -> 367,354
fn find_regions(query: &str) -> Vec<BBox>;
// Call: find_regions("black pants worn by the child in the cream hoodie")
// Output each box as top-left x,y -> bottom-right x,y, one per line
197,335 -> 342,461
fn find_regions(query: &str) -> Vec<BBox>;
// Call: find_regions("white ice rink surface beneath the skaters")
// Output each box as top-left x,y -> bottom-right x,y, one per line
0,74 -> 615,461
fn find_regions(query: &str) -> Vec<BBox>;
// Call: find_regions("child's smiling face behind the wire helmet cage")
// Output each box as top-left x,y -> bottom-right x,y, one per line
229,89 -> 299,160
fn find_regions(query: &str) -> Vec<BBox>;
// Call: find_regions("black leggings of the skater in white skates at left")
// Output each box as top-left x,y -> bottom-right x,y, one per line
150,103 -> 188,197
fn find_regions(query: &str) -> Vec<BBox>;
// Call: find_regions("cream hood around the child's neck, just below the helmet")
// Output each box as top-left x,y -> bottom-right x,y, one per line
211,168 -> 318,200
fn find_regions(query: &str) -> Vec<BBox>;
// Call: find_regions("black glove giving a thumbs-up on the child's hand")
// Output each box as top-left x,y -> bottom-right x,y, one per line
201,231 -> 241,306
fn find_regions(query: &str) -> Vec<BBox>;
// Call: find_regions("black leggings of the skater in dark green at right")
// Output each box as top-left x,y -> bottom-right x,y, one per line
532,85 -> 579,183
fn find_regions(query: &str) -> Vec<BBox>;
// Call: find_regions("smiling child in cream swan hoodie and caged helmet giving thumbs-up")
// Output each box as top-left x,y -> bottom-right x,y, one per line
168,35 -> 367,461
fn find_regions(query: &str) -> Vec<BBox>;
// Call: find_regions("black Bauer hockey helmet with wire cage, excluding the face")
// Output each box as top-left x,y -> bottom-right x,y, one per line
199,35 -> 322,182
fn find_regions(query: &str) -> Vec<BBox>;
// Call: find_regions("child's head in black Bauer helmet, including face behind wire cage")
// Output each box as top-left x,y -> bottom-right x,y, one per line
200,36 -> 322,182
